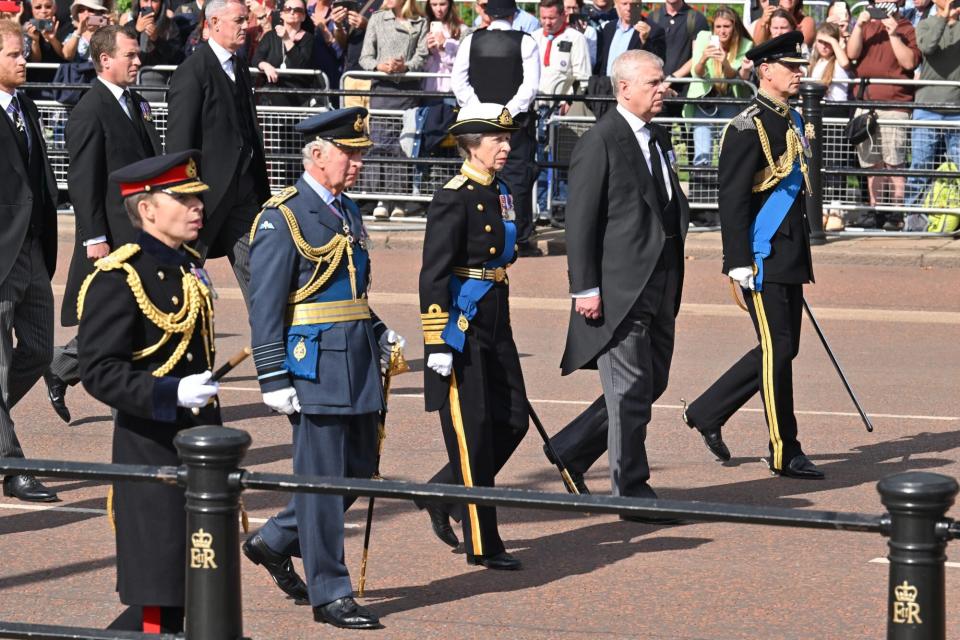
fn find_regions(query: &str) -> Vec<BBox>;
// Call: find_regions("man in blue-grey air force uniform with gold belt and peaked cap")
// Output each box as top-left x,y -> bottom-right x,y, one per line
243,108 -> 404,629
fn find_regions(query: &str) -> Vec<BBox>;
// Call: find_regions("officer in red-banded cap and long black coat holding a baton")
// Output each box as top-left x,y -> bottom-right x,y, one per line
77,150 -> 220,633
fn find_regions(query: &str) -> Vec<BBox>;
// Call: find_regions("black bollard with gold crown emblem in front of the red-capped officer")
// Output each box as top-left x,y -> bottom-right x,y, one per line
174,426 -> 250,640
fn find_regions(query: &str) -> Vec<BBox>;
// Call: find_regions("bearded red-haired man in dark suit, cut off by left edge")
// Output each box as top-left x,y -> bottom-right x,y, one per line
0,20 -> 57,502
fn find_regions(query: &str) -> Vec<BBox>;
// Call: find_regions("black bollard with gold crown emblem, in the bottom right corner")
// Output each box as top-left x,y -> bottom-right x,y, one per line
877,472 -> 960,640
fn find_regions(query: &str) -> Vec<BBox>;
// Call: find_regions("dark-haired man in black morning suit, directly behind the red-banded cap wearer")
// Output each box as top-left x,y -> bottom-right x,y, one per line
44,25 -> 161,422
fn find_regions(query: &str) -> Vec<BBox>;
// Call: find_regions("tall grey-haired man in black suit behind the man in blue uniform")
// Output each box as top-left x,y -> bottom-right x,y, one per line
167,0 -> 270,302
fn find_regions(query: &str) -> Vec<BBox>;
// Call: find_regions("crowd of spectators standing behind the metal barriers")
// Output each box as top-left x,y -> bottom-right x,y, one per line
7,0 -> 960,230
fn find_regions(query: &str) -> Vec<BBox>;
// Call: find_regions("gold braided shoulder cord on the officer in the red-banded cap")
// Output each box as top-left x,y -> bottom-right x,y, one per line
77,244 -> 214,378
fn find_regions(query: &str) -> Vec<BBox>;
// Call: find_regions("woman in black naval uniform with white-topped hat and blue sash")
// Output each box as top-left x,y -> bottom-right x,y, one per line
420,103 -> 529,570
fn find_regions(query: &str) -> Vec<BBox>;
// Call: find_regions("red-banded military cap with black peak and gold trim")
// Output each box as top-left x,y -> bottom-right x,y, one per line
110,149 -> 210,198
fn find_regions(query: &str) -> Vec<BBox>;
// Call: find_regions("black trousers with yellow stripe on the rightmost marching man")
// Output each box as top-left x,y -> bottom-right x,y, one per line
687,282 -> 803,470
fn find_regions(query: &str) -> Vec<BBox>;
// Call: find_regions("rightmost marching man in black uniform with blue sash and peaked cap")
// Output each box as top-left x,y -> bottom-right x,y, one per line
684,31 -> 823,479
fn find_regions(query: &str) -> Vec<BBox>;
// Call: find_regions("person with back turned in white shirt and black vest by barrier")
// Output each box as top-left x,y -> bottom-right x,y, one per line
450,0 -> 540,256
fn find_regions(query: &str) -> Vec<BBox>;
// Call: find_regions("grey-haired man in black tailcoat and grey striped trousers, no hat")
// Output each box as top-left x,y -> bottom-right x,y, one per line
552,50 -> 689,510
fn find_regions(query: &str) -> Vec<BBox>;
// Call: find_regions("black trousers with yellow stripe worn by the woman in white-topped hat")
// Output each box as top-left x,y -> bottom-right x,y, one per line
430,286 -> 529,556
